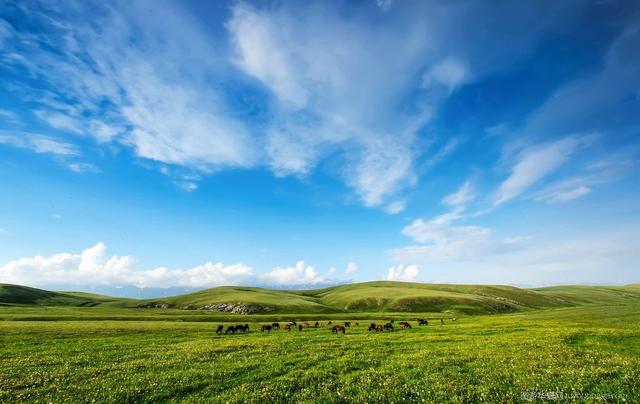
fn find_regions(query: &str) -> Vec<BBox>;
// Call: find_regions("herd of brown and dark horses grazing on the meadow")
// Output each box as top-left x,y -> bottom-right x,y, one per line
216,317 -> 456,334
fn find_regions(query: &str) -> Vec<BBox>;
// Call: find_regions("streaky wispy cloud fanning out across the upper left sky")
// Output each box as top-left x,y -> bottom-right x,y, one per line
7,1 -> 258,176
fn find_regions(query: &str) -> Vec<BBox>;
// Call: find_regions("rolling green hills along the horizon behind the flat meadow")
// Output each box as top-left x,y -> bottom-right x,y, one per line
0,282 -> 640,314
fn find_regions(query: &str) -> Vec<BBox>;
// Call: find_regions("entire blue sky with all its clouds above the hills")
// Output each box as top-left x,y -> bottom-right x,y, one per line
0,0 -> 640,294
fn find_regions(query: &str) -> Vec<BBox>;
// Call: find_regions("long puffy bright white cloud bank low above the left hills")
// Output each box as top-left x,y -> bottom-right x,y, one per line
0,243 -> 253,288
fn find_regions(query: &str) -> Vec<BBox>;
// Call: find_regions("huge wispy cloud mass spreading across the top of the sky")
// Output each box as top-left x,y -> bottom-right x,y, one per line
0,0 -> 600,206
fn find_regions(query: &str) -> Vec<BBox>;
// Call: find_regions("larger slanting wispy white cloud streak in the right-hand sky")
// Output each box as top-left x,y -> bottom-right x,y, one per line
494,136 -> 588,206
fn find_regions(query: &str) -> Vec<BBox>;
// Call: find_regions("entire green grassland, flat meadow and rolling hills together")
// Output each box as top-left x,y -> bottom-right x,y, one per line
0,282 -> 640,403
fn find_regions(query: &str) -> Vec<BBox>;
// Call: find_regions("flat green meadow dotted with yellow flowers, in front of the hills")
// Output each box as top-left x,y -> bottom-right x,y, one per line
0,304 -> 640,402
